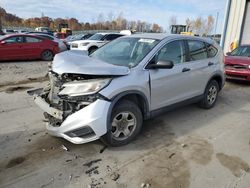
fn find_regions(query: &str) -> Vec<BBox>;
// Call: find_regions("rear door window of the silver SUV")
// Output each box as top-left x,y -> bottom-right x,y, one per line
187,40 -> 207,61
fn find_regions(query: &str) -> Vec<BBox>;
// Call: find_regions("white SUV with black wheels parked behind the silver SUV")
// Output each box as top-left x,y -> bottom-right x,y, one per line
70,33 -> 124,54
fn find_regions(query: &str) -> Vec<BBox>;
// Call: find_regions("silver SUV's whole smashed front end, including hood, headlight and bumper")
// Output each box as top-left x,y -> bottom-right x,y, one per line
29,51 -> 130,144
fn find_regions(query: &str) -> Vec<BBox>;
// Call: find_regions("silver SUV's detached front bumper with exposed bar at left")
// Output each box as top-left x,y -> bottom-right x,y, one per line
35,96 -> 111,144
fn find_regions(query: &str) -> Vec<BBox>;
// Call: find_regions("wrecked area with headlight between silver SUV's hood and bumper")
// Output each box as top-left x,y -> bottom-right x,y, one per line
40,71 -> 111,126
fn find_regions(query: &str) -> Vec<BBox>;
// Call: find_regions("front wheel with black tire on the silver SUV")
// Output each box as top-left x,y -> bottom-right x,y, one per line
101,100 -> 143,147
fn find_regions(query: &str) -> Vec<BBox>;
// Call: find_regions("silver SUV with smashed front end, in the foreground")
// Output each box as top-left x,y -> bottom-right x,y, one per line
31,34 -> 224,146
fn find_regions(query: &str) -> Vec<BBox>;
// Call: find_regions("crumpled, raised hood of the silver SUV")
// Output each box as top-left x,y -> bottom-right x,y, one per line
52,50 -> 130,76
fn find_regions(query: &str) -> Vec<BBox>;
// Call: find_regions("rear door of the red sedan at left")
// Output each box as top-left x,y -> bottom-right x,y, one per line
22,36 -> 43,59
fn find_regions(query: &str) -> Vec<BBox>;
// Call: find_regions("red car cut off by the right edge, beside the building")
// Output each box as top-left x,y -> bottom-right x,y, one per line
225,45 -> 250,81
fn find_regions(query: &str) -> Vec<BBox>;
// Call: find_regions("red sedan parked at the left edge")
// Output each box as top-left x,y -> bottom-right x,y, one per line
0,34 -> 59,61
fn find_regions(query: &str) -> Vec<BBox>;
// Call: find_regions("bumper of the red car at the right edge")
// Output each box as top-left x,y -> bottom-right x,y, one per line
225,69 -> 250,81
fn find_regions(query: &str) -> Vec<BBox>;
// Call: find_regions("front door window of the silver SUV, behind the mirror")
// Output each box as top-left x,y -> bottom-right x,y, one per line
155,41 -> 185,64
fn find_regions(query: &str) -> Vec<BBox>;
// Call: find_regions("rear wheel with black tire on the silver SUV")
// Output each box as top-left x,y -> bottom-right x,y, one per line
199,80 -> 219,109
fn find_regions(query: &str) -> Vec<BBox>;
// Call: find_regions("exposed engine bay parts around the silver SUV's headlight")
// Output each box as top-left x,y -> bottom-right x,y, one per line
33,71 -> 111,127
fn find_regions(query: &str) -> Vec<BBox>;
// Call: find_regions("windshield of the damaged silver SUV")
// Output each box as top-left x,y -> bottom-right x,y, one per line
90,38 -> 159,67
